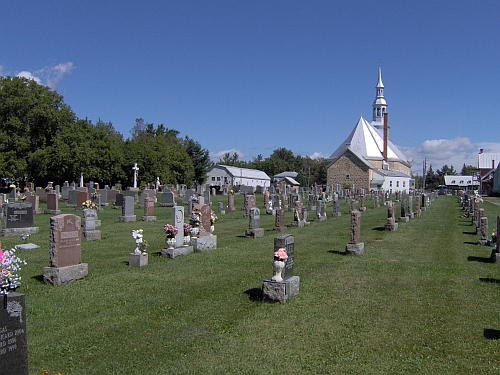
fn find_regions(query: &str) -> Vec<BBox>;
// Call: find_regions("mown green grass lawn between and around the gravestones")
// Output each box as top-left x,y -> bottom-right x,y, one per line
2,195 -> 500,375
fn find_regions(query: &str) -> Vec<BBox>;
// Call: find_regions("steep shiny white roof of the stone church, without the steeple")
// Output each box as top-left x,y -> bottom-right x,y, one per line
329,116 -> 407,163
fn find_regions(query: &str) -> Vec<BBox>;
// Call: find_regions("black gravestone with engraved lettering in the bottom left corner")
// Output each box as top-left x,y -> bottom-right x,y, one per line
0,292 -> 28,375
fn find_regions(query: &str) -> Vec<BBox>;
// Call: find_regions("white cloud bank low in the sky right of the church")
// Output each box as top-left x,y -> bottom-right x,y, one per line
399,137 -> 500,175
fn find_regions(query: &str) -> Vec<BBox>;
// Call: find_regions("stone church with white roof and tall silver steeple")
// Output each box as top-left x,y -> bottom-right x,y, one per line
327,67 -> 415,192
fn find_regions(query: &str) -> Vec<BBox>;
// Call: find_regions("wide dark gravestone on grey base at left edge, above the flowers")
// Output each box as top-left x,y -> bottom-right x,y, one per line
2,202 -> 38,237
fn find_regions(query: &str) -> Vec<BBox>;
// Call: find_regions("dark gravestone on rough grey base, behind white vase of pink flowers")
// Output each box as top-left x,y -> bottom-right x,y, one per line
262,234 -> 300,303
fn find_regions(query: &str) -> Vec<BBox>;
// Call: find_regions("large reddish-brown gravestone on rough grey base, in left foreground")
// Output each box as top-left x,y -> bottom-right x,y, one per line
43,214 -> 88,285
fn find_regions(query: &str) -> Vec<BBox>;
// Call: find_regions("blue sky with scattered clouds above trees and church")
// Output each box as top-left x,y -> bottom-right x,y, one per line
0,0 -> 500,174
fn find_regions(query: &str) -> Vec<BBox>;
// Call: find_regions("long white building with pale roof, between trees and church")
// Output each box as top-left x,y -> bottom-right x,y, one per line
205,165 -> 271,188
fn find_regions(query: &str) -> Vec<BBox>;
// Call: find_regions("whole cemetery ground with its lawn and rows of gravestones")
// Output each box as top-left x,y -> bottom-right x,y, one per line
0,191 -> 500,375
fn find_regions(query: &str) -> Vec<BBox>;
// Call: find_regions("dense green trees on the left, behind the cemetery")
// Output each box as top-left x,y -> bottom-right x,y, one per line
0,77 -> 212,187
